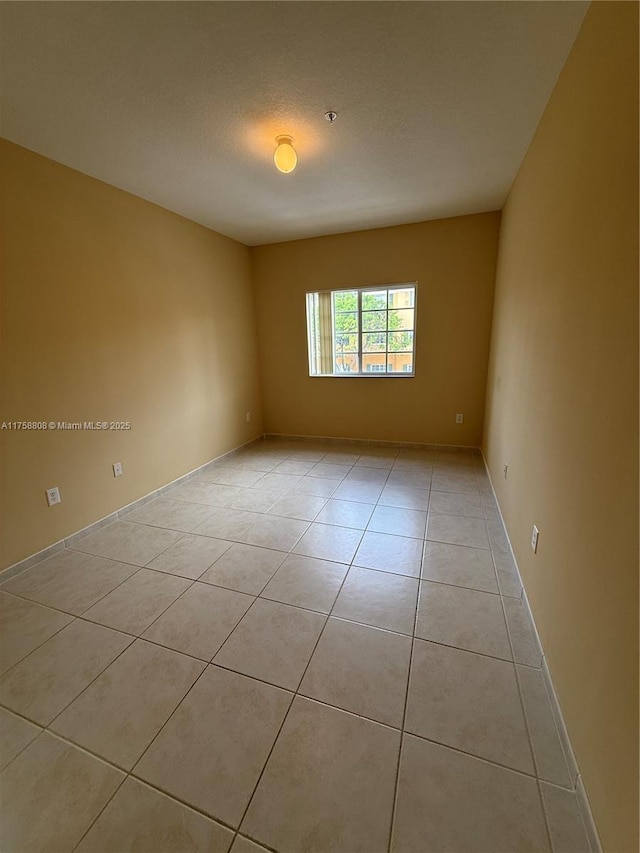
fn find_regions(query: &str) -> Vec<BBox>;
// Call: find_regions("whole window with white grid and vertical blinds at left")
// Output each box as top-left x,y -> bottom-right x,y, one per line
307,284 -> 416,376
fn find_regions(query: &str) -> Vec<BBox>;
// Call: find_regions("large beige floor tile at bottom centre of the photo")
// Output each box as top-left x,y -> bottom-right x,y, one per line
242,697 -> 400,853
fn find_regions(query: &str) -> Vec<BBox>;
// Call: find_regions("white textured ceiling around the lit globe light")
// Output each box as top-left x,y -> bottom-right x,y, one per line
0,0 -> 588,245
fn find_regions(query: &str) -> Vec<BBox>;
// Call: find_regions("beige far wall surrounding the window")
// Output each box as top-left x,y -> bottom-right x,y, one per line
251,213 -> 500,446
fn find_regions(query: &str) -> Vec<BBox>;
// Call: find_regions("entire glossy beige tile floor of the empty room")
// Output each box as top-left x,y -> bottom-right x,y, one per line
0,441 -> 589,853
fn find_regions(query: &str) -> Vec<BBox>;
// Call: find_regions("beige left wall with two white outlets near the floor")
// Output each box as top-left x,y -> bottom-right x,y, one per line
0,142 -> 262,567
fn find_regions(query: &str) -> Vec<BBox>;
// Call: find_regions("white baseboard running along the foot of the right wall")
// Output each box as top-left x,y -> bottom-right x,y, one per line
480,449 -> 603,853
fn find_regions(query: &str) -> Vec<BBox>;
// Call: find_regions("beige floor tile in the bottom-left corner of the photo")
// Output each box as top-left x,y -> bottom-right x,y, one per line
0,732 -> 124,853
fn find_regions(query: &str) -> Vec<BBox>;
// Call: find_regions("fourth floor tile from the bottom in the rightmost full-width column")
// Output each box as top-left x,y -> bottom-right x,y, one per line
422,542 -> 498,592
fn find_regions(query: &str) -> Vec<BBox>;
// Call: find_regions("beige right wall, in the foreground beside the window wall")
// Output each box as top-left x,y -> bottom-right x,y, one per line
484,3 -> 638,853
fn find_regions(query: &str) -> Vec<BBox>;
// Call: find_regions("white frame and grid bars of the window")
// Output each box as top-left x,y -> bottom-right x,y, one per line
305,281 -> 418,379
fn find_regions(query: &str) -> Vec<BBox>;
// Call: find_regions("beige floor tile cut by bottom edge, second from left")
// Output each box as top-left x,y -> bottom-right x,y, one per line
75,777 -> 233,853
